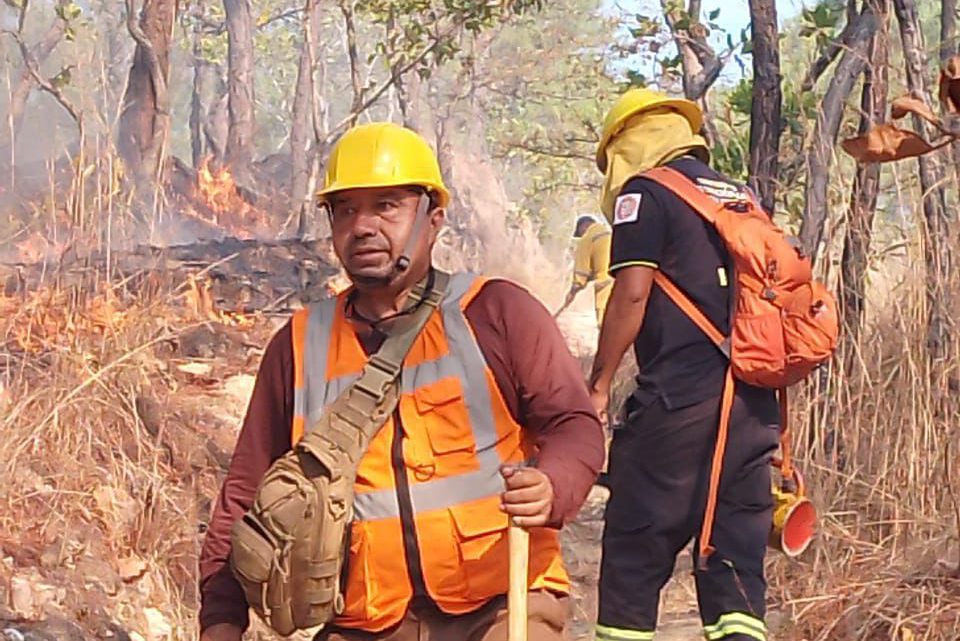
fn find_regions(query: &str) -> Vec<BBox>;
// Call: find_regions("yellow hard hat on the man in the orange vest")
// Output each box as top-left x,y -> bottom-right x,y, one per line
317,122 -> 450,207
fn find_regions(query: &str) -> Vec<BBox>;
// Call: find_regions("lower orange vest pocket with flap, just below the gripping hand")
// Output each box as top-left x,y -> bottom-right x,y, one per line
450,497 -> 509,600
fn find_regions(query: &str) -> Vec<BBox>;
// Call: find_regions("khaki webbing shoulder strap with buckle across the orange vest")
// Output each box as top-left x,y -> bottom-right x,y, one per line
296,271 -> 450,477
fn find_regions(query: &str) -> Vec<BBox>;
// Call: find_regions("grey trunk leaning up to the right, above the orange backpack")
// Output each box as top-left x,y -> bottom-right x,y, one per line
800,6 -> 877,260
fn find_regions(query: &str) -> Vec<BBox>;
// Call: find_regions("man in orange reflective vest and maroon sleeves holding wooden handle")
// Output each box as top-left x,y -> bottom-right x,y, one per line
200,123 -> 603,641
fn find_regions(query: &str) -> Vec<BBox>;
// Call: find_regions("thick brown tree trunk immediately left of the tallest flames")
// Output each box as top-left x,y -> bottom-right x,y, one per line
117,0 -> 177,198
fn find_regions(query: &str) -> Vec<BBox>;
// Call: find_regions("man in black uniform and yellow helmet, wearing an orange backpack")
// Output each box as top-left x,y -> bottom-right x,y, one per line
590,89 -> 778,641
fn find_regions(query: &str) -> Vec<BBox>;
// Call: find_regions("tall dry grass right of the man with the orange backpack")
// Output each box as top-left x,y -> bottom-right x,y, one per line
770,252 -> 960,641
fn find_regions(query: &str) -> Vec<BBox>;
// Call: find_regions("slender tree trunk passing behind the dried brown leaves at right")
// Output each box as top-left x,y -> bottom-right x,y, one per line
893,0 -> 950,358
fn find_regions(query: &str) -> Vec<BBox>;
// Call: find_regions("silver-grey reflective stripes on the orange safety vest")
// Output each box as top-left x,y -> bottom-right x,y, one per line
294,274 -> 504,521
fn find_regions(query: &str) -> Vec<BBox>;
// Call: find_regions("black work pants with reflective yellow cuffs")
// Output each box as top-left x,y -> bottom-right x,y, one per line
596,385 -> 779,641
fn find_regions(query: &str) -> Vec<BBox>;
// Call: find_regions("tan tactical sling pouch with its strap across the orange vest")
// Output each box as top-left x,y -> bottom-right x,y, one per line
230,271 -> 449,636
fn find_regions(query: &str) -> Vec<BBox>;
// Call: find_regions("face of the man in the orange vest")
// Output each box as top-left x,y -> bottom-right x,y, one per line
329,187 -> 443,286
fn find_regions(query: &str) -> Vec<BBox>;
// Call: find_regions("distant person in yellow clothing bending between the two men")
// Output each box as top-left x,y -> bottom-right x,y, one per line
563,214 -> 613,326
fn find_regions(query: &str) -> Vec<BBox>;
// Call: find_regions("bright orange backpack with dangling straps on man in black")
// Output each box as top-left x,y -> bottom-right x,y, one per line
642,167 -> 840,565
